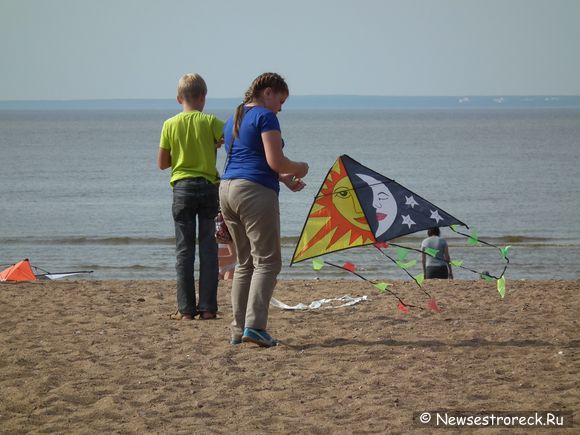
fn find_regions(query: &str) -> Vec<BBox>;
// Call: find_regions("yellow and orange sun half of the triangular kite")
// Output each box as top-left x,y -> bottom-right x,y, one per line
293,160 -> 375,261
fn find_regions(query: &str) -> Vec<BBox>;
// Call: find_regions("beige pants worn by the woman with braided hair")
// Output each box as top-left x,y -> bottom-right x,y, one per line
220,179 -> 282,339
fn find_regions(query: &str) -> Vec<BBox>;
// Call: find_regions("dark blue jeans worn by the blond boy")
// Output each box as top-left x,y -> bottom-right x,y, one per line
172,178 -> 218,315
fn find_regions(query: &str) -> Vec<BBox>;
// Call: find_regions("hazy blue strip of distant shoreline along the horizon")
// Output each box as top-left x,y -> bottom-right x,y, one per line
0,95 -> 580,110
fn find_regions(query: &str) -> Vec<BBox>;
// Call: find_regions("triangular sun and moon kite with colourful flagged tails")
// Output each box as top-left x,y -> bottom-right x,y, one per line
291,155 -> 510,313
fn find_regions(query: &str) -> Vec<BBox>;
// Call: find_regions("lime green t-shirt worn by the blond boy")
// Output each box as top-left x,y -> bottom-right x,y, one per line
159,111 -> 224,186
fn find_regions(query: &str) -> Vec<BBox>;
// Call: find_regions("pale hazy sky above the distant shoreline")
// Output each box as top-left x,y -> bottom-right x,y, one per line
0,0 -> 580,100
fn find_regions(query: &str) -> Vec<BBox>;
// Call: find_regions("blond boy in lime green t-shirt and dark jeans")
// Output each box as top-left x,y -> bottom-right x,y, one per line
157,74 -> 224,320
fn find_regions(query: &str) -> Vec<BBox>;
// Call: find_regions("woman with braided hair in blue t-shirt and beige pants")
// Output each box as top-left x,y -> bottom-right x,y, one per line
220,73 -> 308,347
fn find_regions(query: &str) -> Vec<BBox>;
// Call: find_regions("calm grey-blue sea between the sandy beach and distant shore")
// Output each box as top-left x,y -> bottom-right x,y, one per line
0,109 -> 580,280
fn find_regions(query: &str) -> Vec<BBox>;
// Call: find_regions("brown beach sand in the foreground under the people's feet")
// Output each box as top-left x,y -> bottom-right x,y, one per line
0,280 -> 580,434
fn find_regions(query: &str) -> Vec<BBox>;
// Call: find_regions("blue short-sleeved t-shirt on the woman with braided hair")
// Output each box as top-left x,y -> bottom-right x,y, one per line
221,106 -> 280,193
